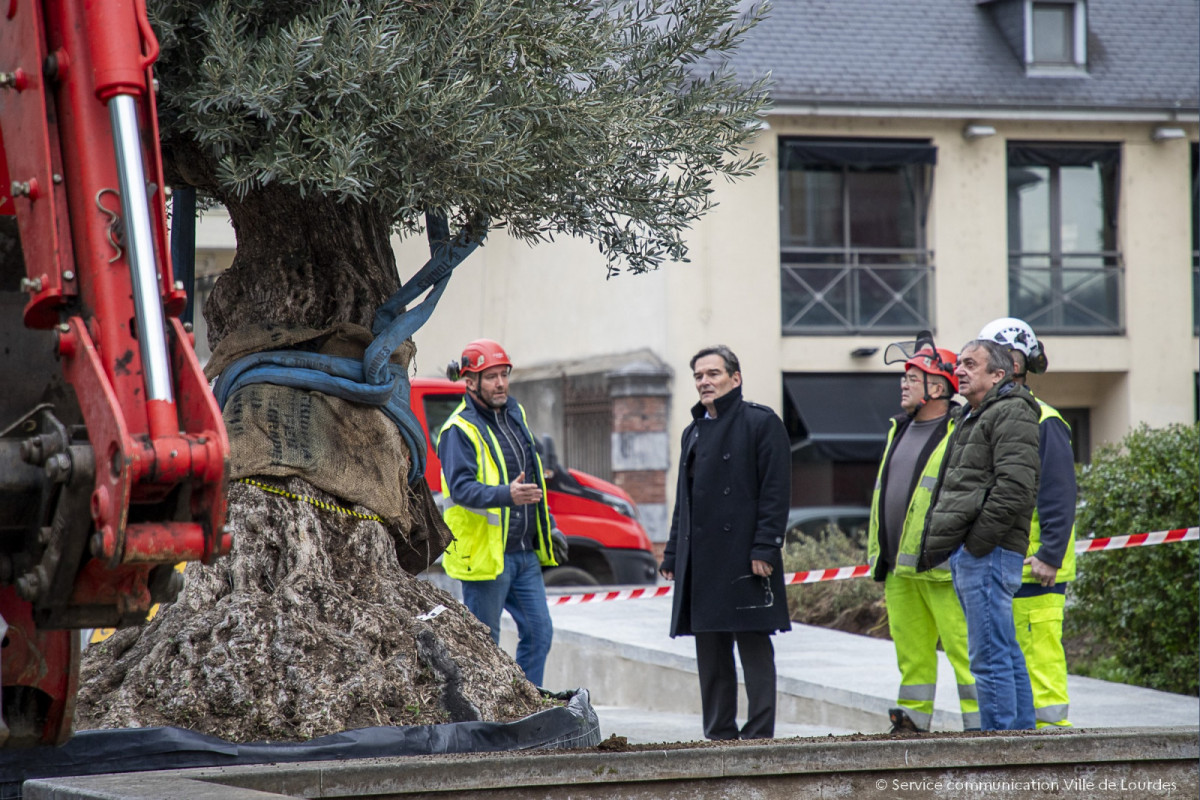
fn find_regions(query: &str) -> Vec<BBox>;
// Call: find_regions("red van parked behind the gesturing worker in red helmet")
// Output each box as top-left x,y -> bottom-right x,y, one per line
409,378 -> 658,587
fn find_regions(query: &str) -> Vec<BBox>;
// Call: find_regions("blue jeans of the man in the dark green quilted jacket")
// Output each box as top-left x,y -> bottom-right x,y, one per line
950,547 -> 1034,730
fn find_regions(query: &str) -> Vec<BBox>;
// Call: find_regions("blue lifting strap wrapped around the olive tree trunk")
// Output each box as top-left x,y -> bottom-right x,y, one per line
212,213 -> 480,485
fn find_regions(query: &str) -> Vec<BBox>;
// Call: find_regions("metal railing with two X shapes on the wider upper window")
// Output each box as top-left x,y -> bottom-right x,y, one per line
780,247 -> 934,333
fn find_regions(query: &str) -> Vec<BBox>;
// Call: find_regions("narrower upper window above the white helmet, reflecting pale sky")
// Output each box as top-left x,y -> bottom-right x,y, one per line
1008,142 -> 1124,333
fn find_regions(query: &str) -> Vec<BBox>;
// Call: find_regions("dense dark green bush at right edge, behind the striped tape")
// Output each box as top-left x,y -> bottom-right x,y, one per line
1066,425 -> 1200,696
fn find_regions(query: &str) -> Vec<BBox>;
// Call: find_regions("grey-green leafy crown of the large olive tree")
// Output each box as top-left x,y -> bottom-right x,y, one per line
150,0 -> 766,272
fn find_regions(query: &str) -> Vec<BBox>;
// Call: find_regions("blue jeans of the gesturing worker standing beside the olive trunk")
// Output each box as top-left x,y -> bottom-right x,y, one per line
462,551 -> 554,686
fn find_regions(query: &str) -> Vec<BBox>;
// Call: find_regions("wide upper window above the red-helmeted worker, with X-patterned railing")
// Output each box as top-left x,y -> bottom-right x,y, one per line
779,139 -> 936,333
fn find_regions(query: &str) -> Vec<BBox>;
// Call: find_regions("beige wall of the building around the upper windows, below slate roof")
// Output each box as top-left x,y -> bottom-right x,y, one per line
192,116 -> 1200,513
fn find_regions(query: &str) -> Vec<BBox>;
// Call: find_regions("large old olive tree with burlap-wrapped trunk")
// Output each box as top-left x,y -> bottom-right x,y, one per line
80,0 -> 766,740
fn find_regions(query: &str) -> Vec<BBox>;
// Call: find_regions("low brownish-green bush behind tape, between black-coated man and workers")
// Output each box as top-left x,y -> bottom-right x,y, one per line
784,528 -> 888,638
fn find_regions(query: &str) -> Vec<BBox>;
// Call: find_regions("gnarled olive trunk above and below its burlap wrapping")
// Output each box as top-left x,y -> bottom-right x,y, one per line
77,178 -> 541,741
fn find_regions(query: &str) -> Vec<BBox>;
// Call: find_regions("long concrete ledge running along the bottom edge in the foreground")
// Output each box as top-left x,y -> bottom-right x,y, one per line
24,728 -> 1200,800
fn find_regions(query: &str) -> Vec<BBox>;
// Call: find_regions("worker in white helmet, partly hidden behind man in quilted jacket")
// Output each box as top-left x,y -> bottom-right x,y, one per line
979,317 -> 1078,728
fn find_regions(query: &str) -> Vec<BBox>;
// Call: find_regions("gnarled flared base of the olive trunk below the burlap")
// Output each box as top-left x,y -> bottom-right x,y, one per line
78,479 -> 541,741
